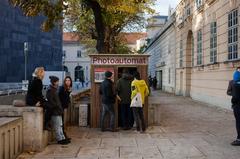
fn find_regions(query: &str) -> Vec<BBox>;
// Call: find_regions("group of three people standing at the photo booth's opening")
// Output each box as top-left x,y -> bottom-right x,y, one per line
99,70 -> 149,133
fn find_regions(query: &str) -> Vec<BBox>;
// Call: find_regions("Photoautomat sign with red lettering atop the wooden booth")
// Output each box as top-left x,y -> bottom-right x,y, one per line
91,56 -> 148,65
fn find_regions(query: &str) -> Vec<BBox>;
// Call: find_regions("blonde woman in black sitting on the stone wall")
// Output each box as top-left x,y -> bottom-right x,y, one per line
26,67 -> 46,107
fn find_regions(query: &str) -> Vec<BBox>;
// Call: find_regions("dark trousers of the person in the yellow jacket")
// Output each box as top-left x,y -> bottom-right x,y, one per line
132,107 -> 146,131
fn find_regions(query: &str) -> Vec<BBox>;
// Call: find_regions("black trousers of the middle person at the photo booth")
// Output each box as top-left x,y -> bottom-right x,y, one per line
120,104 -> 134,128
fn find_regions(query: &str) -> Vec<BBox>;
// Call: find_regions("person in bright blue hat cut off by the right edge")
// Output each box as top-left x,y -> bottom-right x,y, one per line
227,67 -> 240,146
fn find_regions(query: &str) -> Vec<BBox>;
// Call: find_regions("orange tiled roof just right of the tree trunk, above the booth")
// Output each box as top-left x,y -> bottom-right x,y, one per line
120,32 -> 147,45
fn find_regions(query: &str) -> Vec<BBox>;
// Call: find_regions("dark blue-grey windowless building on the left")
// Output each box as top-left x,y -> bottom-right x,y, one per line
0,0 -> 62,82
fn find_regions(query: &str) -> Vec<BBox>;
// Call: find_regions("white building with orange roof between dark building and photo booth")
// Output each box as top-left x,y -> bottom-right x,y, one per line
63,33 -> 90,83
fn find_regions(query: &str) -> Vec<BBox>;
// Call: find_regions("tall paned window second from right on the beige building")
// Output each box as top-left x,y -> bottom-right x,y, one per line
210,22 -> 217,63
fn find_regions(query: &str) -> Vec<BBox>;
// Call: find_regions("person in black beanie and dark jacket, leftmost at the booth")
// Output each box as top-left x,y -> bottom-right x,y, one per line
99,71 -> 116,132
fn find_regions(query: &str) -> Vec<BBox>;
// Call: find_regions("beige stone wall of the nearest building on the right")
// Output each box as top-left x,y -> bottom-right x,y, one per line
176,0 -> 240,109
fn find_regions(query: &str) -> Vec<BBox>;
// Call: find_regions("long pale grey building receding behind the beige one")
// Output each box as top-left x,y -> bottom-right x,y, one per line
145,14 -> 176,93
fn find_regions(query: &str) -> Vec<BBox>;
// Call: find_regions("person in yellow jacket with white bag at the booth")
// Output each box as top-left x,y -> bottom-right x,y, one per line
131,72 -> 149,133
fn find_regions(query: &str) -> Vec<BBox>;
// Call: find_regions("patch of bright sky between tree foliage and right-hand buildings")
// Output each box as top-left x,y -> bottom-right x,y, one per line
153,0 -> 180,15
